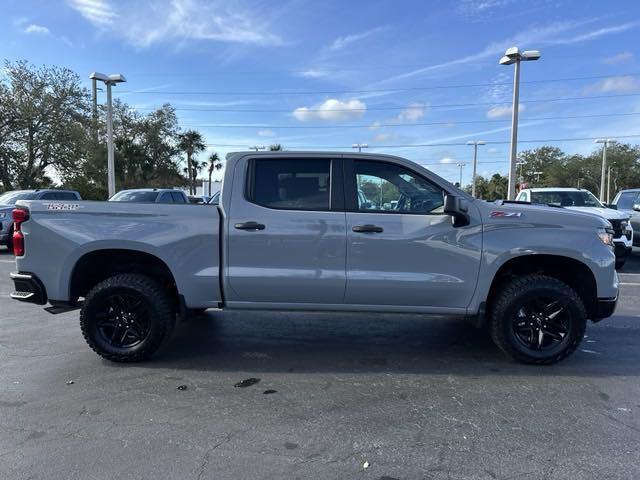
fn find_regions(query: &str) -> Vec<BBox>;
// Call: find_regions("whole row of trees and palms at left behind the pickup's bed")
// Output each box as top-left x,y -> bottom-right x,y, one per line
0,61 -> 222,200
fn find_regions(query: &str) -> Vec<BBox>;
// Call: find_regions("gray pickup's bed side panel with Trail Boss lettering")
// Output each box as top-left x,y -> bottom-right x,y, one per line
16,201 -> 221,308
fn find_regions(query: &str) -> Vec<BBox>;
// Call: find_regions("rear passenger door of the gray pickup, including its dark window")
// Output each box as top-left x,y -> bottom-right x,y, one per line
227,155 -> 346,305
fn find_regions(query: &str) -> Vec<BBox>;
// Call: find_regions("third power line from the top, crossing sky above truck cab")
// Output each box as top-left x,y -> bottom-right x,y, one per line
178,112 -> 640,129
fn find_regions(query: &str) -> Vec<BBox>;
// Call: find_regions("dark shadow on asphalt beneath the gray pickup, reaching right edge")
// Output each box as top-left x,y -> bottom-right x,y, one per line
147,312 -> 640,376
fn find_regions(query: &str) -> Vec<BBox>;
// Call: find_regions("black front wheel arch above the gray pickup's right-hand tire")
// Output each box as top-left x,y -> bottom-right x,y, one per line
486,254 -> 598,318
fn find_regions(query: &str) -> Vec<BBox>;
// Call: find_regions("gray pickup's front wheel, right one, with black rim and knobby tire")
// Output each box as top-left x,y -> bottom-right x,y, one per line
489,275 -> 587,365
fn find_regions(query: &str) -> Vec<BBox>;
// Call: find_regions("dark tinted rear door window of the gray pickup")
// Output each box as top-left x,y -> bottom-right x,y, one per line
248,158 -> 331,210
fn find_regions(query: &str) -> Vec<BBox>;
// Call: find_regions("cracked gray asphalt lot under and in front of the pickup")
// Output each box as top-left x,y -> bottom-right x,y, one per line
0,250 -> 640,480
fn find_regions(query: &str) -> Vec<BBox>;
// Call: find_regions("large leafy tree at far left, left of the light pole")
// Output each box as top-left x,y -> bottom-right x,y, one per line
0,61 -> 90,190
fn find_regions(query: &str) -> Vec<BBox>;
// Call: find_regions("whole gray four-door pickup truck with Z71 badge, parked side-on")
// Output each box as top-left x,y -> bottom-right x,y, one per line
11,152 -> 618,364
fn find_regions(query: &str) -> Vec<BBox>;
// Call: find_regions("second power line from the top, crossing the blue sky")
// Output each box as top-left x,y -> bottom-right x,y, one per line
132,92 -> 640,113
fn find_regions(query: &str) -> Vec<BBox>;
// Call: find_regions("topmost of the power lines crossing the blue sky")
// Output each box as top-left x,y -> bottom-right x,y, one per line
119,72 -> 640,96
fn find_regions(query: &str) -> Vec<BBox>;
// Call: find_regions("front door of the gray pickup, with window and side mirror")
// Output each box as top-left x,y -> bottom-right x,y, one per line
345,159 -> 482,308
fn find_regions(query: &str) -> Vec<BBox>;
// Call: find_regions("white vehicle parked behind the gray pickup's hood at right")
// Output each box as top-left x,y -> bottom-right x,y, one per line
516,187 -> 633,268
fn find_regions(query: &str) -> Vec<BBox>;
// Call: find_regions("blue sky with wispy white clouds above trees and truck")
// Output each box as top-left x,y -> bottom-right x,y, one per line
0,0 -> 640,183
